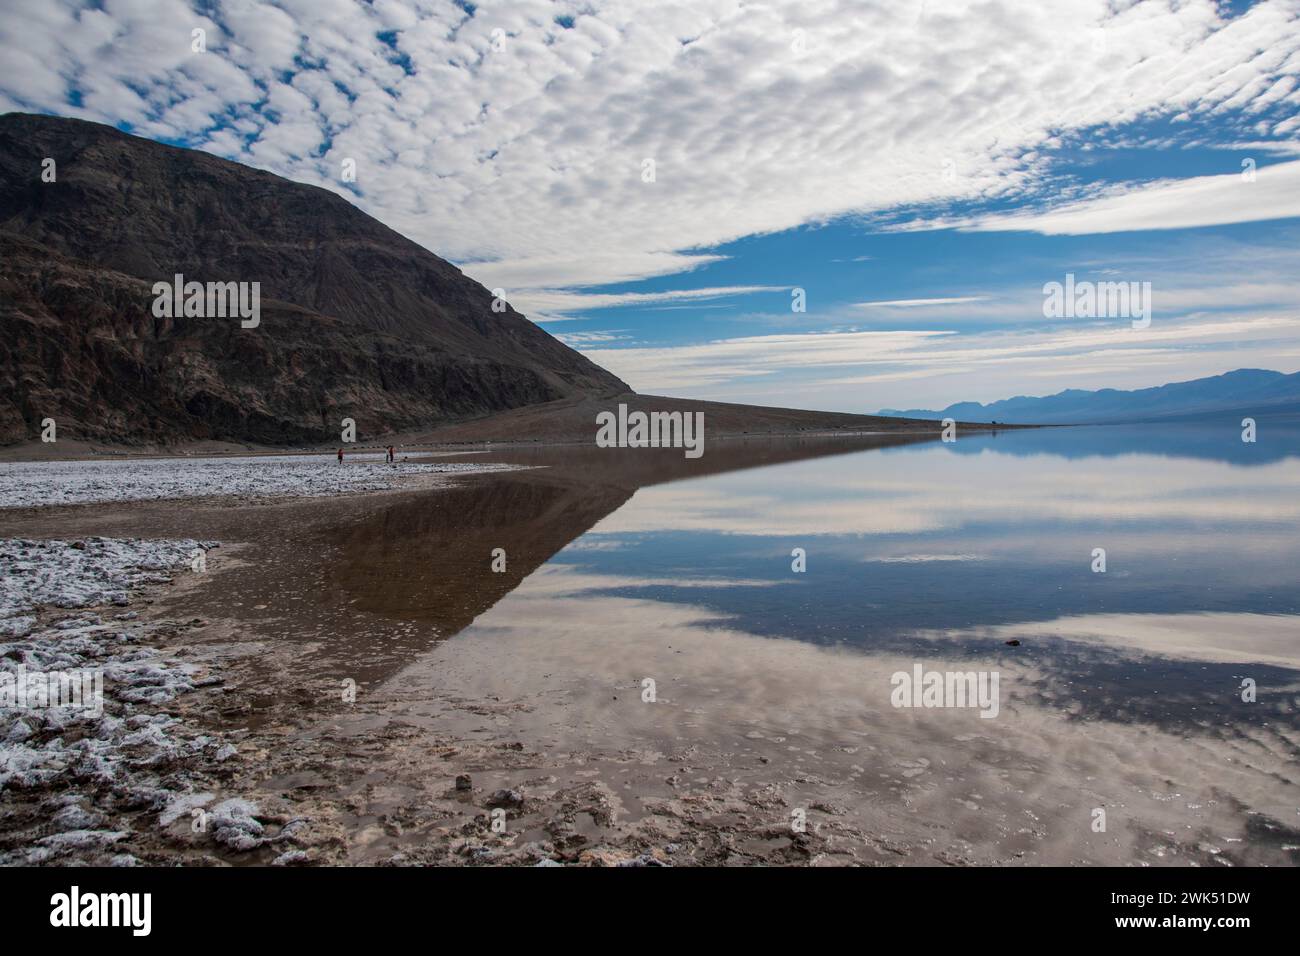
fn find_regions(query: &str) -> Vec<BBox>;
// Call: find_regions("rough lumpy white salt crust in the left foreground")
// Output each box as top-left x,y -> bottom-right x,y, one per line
0,537 -> 231,865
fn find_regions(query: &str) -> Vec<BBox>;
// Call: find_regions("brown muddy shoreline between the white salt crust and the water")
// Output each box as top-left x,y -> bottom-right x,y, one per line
0,476 -> 842,865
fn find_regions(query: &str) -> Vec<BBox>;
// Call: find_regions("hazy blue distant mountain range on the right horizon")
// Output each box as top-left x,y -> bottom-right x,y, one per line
880,368 -> 1300,424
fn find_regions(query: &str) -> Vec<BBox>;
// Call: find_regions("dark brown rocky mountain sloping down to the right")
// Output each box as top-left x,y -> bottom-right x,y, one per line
0,113 -> 629,445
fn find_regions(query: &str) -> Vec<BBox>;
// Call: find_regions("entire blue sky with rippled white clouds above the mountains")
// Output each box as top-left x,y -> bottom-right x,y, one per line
0,0 -> 1300,411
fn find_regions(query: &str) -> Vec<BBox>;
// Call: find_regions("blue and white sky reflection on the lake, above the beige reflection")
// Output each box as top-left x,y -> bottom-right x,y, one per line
520,427 -> 1300,721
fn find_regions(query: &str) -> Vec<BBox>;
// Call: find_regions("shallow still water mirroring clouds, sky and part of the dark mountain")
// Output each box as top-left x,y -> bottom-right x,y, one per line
339,427 -> 1300,864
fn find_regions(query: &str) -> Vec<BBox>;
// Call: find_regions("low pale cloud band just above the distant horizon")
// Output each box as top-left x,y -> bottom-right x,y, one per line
582,310 -> 1300,411
